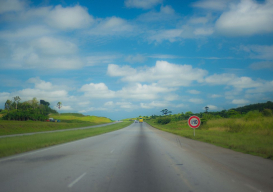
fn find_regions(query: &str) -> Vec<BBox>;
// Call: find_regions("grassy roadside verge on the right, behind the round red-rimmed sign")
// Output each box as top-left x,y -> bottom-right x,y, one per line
146,117 -> 273,160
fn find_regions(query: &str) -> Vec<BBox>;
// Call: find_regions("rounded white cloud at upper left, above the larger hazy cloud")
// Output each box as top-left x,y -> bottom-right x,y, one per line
46,5 -> 94,30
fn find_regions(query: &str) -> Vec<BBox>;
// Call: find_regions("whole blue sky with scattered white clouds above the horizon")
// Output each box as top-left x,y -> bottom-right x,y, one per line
0,0 -> 273,120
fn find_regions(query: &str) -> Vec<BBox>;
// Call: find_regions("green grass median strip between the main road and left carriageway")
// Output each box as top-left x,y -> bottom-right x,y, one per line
0,121 -> 132,157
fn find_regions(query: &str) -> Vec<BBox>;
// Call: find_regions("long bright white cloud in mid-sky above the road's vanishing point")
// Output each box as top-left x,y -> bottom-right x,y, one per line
107,61 -> 207,86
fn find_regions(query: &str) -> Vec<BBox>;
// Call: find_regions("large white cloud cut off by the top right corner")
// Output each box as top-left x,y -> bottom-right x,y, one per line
215,0 -> 273,36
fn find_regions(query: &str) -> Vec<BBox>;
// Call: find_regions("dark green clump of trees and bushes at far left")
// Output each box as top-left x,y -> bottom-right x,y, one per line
1,96 -> 58,121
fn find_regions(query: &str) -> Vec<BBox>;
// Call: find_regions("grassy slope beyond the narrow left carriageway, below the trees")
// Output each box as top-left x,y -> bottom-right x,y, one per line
0,113 -> 112,135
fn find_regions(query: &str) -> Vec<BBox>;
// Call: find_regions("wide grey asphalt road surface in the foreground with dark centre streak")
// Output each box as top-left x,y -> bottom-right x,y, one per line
0,123 -> 273,192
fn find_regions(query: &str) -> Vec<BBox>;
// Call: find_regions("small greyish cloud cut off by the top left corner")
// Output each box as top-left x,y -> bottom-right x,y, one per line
0,0 -> 25,14
